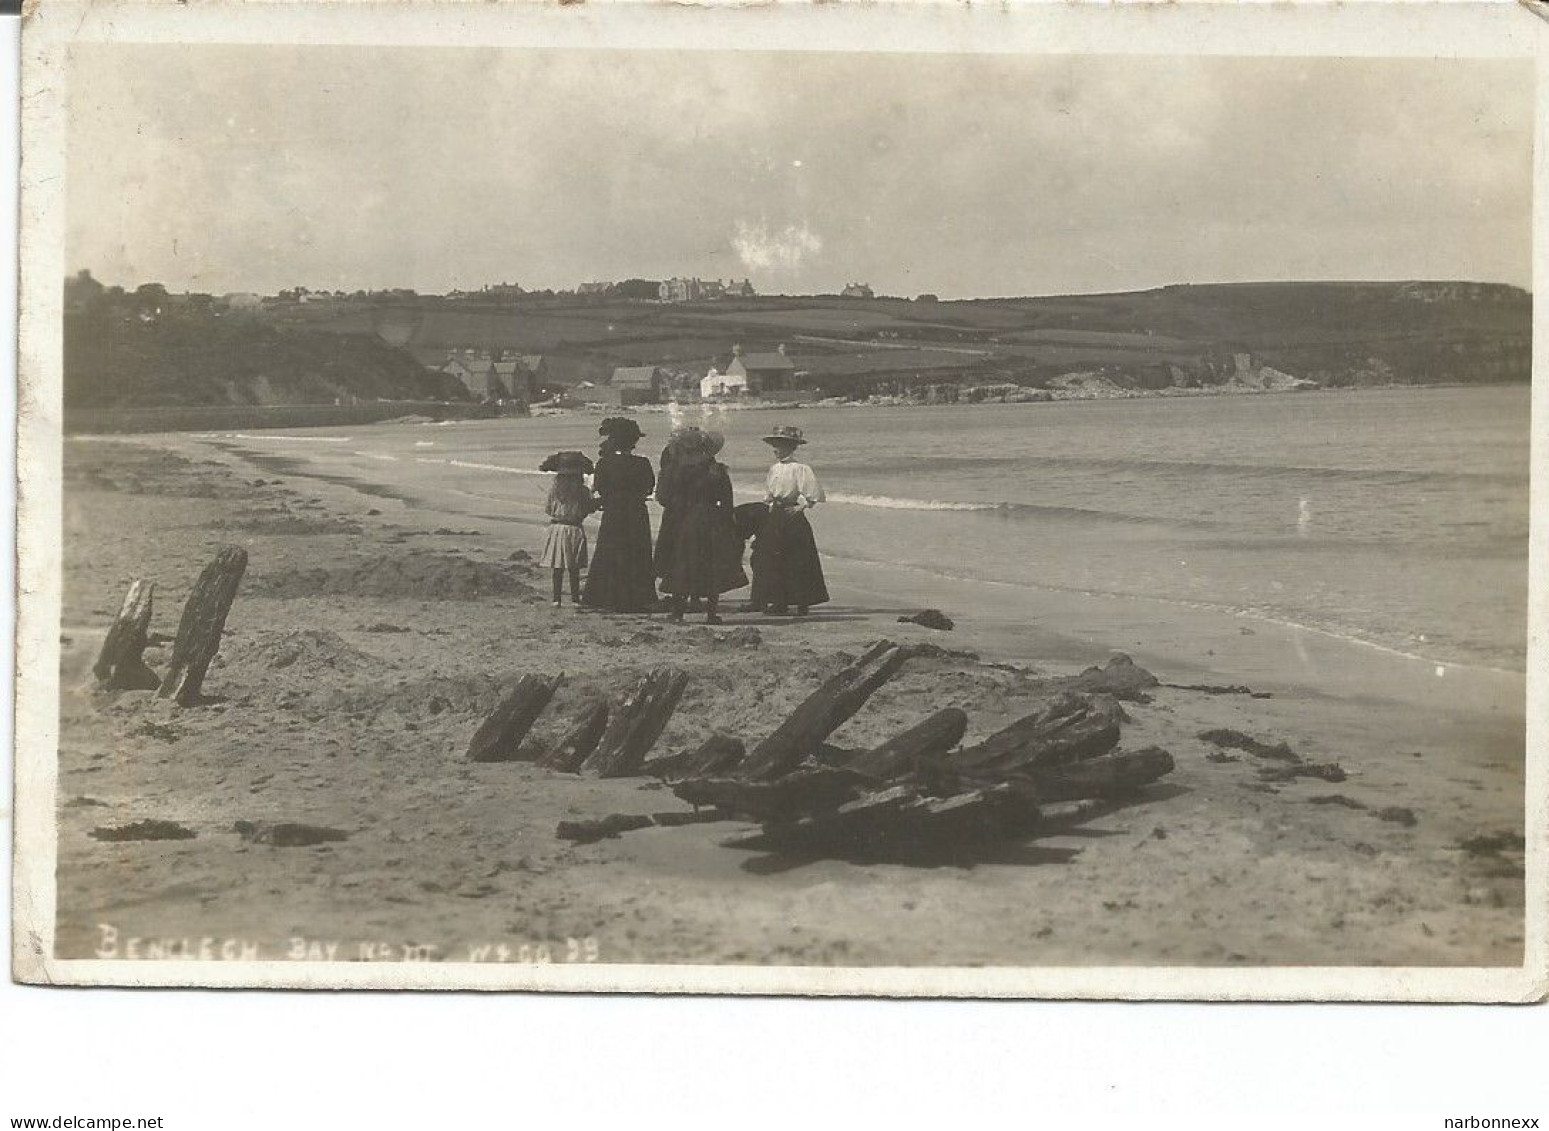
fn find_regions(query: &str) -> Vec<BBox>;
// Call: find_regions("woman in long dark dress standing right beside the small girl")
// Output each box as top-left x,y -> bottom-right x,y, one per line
581,417 -> 657,612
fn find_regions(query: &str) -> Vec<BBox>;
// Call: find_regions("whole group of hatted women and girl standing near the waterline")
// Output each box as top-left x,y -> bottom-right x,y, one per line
541,417 -> 829,624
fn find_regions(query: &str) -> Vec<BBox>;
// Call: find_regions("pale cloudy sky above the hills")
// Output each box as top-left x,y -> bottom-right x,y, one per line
67,45 -> 1534,297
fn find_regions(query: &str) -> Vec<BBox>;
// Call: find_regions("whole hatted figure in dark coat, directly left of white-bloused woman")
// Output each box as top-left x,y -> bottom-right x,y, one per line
657,428 -> 748,624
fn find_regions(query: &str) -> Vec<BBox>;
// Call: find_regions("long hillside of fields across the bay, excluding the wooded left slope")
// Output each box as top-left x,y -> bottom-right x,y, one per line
271,282 -> 1532,395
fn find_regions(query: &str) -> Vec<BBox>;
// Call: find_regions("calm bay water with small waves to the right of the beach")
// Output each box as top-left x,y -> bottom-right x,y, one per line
263,387 -> 1529,669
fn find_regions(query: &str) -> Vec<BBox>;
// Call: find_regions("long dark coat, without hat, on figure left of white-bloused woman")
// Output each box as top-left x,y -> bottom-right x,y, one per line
657,462 -> 748,596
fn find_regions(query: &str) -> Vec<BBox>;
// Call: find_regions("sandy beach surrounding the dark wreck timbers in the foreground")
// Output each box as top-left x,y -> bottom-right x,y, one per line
57,437 -> 1523,965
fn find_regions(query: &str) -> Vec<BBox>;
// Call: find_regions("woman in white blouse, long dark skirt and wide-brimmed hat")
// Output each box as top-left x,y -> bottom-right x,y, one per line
751,425 -> 829,617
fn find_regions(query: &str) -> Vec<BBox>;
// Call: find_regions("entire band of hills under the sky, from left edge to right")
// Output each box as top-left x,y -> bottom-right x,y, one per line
65,282 -> 1532,407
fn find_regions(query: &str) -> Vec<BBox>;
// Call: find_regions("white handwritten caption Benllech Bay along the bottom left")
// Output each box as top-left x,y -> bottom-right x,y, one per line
93,923 -> 603,965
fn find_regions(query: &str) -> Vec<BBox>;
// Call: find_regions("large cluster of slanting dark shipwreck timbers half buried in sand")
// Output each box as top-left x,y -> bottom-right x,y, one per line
468,640 -> 1173,861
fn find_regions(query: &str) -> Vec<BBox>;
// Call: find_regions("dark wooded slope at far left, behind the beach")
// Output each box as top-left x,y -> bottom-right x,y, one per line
64,311 -> 468,409
